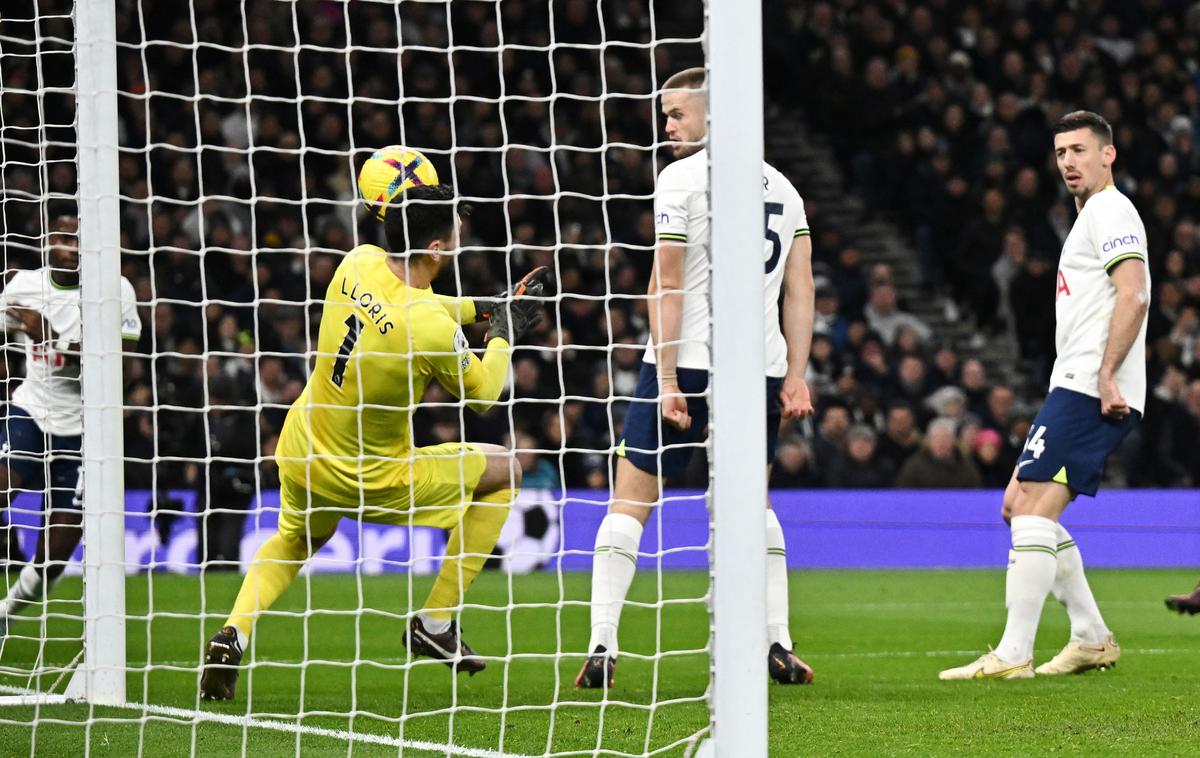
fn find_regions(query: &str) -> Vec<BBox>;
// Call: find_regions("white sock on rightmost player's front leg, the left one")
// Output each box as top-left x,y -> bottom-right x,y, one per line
996,516 -> 1058,663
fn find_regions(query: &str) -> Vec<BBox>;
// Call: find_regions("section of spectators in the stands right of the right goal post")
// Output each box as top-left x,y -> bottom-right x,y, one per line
767,0 -> 1200,487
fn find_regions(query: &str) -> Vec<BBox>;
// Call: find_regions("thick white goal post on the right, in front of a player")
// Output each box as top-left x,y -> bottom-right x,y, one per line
708,0 -> 767,758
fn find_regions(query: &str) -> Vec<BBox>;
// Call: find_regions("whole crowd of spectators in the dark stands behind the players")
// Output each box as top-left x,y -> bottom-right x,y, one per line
5,0 -> 1200,501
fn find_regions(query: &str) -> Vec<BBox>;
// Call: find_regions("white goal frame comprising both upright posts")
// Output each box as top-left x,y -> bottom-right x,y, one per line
0,0 -> 767,758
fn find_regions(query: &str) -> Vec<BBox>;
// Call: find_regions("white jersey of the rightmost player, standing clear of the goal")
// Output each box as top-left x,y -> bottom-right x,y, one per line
1050,186 -> 1150,413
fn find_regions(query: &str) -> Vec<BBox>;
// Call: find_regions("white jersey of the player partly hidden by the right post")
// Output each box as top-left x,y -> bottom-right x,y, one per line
644,150 -> 809,377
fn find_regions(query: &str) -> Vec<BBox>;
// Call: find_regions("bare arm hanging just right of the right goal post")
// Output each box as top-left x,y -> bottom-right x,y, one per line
780,234 -> 816,419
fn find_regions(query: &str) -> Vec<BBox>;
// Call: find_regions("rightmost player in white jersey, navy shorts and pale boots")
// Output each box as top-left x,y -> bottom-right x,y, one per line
940,110 -> 1150,679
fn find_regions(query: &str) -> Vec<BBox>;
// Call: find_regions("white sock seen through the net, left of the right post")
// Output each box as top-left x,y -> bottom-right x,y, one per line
588,513 -> 642,656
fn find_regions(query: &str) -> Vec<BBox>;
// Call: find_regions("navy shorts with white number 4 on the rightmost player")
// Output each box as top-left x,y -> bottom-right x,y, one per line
1016,387 -> 1141,497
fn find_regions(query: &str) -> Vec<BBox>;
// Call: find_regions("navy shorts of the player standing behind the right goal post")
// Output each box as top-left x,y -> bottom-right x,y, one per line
617,362 -> 784,479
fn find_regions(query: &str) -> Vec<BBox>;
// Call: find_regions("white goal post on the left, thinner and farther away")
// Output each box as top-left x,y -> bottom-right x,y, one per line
66,0 -> 126,705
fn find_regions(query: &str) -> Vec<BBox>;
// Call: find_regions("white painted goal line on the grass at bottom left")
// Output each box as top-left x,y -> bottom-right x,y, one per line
0,685 -> 529,758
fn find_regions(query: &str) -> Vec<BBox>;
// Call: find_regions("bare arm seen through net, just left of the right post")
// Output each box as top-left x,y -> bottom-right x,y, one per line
646,242 -> 691,429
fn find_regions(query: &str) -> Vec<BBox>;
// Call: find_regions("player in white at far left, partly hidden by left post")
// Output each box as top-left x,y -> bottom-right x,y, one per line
0,216 -> 142,638
